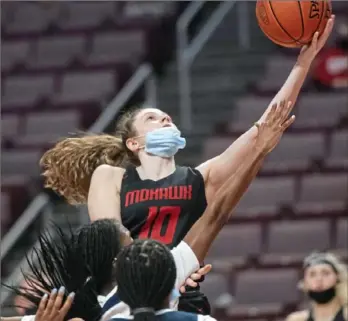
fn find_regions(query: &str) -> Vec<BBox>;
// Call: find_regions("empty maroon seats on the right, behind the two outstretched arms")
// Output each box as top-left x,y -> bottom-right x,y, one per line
202,37 -> 348,320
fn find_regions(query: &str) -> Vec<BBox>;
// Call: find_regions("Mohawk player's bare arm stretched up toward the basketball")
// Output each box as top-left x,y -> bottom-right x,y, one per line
197,16 -> 334,203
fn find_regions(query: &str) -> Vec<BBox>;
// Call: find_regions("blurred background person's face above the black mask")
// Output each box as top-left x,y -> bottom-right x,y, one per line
304,264 -> 337,291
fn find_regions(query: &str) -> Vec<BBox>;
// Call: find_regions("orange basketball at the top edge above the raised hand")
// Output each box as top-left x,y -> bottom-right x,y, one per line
256,0 -> 331,48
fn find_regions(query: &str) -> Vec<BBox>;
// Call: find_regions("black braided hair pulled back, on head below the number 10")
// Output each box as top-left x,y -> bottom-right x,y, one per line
115,240 -> 176,321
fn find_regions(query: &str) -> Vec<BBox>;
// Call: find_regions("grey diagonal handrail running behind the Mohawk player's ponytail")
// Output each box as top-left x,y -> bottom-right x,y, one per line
1,63 -> 156,260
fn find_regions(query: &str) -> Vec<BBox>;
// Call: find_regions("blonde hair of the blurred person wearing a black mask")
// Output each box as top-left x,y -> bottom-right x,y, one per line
299,252 -> 348,306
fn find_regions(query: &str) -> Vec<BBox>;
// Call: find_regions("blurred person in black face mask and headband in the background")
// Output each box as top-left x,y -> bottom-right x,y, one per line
286,253 -> 348,321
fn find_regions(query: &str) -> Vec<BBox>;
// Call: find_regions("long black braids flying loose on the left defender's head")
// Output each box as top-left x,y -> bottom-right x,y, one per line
7,219 -> 122,321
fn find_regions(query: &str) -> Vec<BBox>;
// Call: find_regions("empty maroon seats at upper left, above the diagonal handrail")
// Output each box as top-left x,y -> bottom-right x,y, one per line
1,1 -> 177,235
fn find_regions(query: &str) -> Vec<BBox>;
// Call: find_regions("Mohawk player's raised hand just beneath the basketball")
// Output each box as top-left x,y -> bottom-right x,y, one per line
297,15 -> 335,66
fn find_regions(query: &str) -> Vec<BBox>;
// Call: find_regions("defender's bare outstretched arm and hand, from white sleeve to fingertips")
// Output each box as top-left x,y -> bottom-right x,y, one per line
184,102 -> 295,262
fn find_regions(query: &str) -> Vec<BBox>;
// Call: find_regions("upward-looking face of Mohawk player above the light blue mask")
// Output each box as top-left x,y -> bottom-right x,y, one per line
133,108 -> 176,136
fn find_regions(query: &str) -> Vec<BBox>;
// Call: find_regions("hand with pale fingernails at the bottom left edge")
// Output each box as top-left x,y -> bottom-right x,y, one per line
35,287 -> 83,321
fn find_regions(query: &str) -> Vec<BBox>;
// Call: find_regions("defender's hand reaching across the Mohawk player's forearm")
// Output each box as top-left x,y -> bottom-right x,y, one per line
255,100 -> 295,154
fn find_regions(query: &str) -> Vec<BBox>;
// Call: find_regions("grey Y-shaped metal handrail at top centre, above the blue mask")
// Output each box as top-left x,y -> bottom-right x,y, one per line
176,0 -> 236,131
